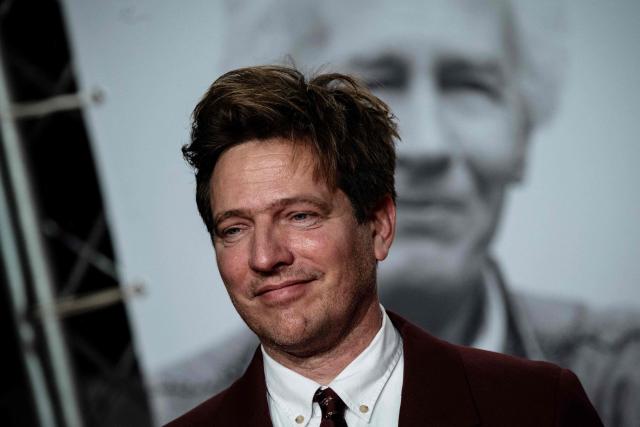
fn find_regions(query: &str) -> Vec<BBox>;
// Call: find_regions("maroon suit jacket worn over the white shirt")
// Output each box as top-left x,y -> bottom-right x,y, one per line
166,313 -> 602,427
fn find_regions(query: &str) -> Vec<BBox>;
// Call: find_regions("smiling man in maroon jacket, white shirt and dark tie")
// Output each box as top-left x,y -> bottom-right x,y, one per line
164,66 -> 602,427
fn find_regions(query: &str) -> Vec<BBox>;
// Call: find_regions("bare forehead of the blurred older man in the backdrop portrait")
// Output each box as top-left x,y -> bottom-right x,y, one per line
314,0 -> 506,65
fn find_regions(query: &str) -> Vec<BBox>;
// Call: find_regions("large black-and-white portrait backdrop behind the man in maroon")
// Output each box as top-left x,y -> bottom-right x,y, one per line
3,0 -> 640,427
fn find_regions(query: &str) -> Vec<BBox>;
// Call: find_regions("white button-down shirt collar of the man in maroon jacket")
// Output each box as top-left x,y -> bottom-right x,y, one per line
261,306 -> 402,425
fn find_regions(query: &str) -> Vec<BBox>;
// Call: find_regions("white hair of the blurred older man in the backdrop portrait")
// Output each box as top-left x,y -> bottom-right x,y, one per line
220,0 -> 567,128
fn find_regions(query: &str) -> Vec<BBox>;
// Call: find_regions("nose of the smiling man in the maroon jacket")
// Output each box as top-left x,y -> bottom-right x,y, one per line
249,224 -> 293,274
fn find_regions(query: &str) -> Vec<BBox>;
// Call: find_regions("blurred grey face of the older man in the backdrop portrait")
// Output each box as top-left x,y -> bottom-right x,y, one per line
321,0 -> 526,288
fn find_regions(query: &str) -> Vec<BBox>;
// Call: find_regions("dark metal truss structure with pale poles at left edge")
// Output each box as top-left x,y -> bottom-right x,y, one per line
0,0 -> 151,427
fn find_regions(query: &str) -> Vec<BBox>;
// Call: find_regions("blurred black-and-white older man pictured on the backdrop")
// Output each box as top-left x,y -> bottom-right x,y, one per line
154,0 -> 640,426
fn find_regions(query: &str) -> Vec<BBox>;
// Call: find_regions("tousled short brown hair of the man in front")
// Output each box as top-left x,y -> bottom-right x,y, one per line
182,65 -> 398,233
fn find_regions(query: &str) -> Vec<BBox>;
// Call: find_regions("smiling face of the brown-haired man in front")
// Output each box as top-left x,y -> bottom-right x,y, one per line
211,138 -> 388,355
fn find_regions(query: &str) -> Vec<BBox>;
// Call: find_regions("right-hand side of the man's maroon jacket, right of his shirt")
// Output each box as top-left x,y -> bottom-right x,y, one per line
389,313 -> 602,427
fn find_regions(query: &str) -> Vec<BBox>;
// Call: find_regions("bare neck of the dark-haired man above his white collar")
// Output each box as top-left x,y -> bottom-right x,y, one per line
264,298 -> 382,385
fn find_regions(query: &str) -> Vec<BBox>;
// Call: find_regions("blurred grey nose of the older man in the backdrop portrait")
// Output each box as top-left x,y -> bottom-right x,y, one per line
397,78 -> 454,179
